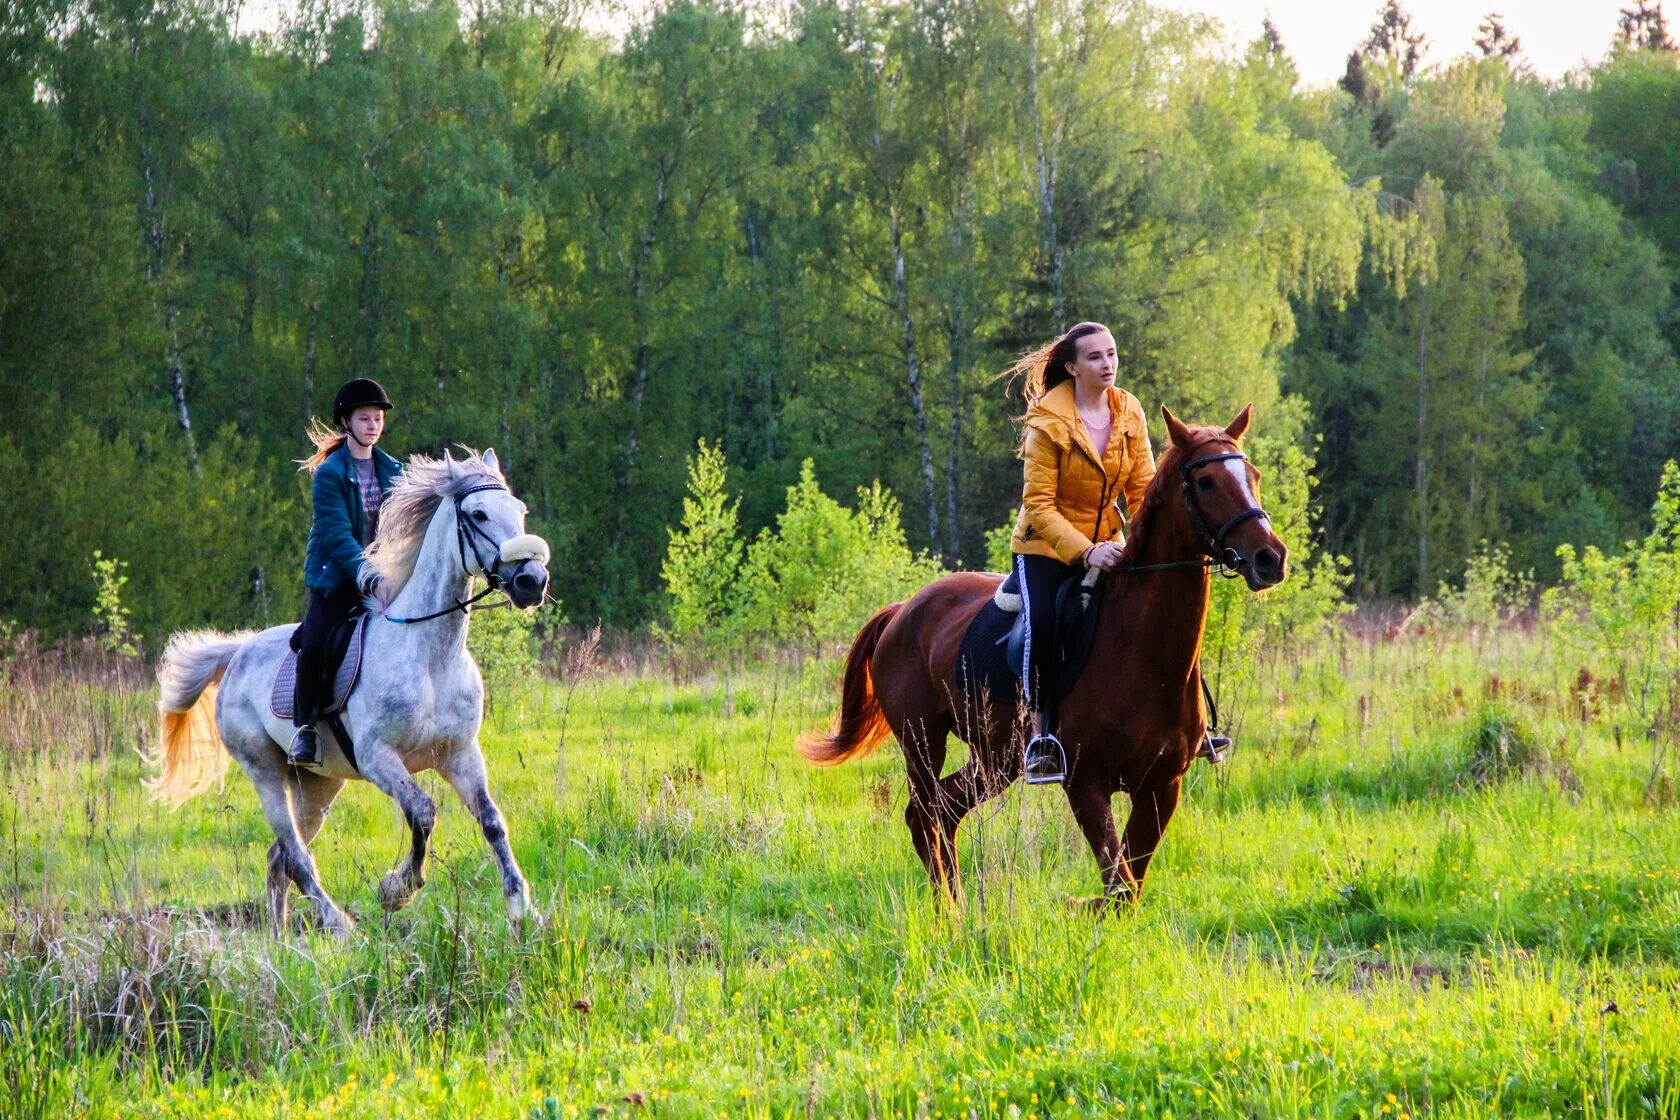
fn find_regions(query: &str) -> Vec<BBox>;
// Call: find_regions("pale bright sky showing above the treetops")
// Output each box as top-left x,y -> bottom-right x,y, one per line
230,0 -> 1633,86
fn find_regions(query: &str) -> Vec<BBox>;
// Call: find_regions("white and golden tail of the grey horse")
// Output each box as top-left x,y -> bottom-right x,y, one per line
143,630 -> 250,808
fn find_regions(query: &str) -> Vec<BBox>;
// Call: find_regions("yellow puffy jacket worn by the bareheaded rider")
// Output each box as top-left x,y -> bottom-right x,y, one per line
1010,381 -> 1154,564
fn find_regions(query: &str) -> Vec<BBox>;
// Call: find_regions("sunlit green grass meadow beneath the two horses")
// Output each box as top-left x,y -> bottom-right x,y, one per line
0,633 -> 1680,1120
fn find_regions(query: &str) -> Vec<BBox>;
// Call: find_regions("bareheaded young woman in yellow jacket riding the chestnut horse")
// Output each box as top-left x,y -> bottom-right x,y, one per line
1010,322 -> 1154,784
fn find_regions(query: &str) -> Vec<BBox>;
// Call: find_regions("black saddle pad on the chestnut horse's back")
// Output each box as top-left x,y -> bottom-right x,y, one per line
958,569 -> 1105,710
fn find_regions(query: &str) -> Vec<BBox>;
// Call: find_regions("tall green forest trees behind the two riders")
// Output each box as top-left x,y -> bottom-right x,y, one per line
0,0 -> 1680,645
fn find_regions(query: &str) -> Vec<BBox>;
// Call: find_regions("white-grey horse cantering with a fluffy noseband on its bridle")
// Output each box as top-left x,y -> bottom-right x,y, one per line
146,450 -> 549,937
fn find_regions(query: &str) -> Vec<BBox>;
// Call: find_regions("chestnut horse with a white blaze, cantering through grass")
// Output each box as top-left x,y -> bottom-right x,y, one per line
801,406 -> 1289,898
